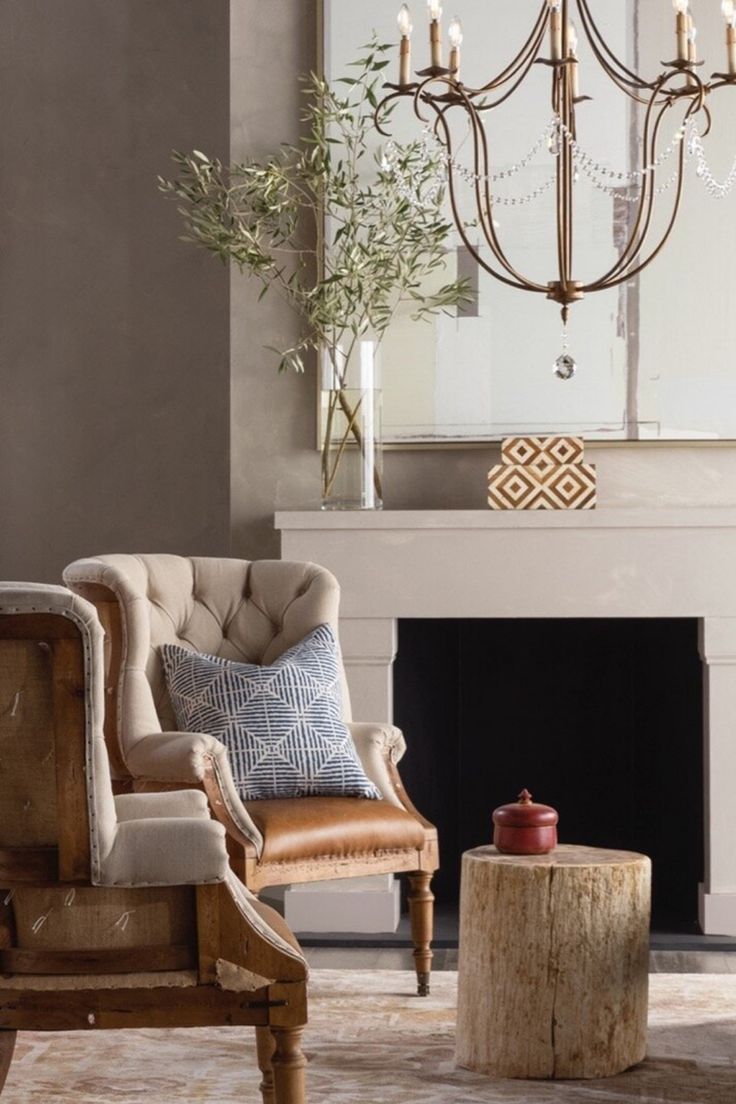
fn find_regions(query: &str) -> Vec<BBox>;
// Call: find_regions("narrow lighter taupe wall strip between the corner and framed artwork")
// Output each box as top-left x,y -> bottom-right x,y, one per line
231,0 -> 319,558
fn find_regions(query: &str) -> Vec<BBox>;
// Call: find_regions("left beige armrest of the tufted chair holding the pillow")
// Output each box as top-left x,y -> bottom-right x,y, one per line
126,732 -> 264,854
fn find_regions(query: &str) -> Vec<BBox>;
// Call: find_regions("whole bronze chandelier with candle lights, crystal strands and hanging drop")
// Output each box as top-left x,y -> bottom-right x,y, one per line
376,0 -> 736,379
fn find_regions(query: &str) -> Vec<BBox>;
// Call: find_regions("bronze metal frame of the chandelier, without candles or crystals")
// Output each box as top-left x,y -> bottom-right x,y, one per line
375,0 -> 736,323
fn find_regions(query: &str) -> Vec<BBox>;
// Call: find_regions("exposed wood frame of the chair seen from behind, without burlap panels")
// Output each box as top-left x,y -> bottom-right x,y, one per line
0,584 -> 307,1104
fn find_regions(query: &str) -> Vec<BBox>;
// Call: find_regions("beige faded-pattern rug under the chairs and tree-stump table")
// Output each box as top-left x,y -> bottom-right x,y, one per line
1,970 -> 736,1104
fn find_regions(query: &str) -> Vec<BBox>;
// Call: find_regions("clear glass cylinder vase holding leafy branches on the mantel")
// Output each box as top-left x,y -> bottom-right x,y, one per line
321,338 -> 383,510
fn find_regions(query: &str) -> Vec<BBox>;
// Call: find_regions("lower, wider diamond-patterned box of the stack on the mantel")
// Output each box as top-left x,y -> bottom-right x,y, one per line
488,463 -> 596,510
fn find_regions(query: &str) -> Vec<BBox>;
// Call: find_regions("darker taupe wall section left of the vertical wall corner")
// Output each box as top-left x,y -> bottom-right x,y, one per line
0,0 -> 230,580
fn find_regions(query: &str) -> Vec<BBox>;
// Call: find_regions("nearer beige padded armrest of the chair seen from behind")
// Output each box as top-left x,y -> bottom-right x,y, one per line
100,817 -> 230,885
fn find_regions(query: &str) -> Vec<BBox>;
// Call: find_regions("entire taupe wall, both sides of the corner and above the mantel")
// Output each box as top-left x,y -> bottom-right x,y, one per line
0,0 -> 736,580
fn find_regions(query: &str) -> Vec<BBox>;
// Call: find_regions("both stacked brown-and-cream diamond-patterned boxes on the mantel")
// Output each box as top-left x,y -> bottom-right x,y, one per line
488,437 -> 596,510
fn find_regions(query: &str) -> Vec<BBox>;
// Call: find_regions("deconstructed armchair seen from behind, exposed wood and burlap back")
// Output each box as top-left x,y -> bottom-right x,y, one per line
0,584 -> 307,1104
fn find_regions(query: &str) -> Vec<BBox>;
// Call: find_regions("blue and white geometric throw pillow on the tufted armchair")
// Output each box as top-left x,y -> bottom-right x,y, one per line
160,625 -> 381,802
